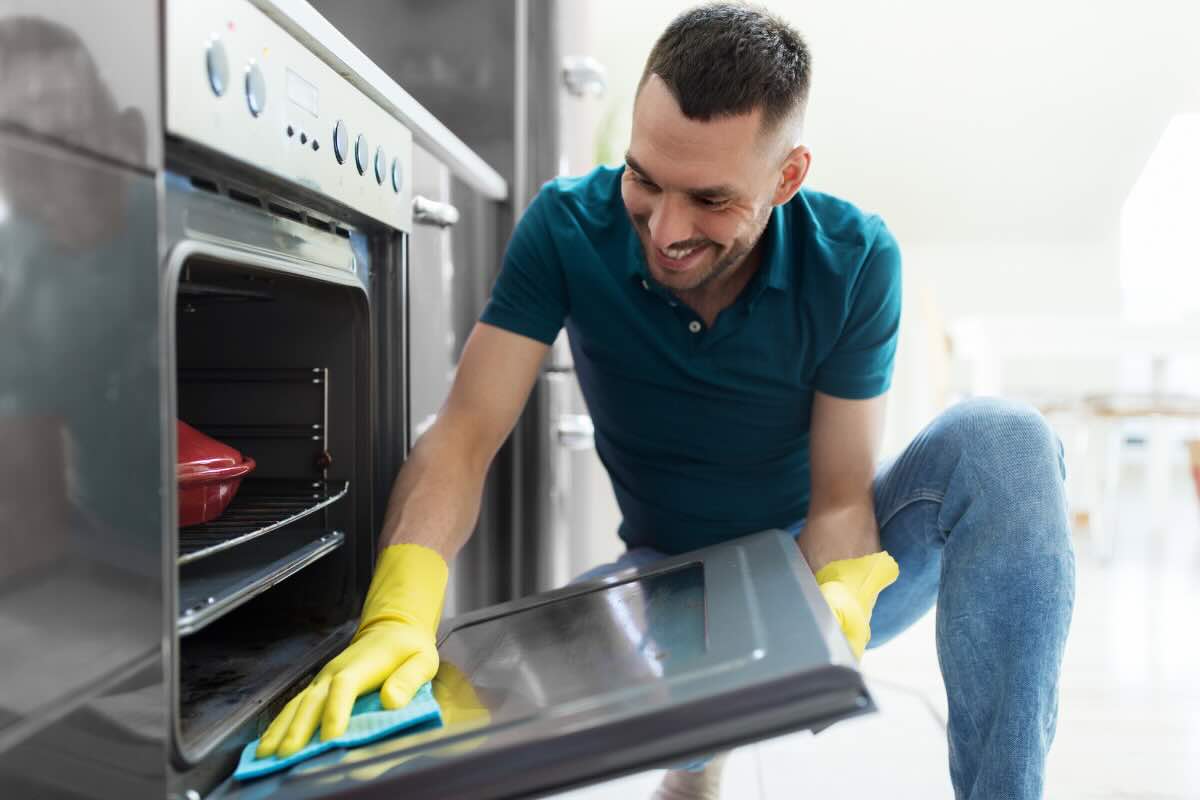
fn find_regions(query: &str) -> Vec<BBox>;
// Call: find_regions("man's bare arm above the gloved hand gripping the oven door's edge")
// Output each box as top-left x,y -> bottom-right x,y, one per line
799,392 -> 887,572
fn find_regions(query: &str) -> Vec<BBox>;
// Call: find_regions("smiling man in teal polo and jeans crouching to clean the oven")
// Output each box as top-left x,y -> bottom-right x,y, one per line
260,4 -> 1074,799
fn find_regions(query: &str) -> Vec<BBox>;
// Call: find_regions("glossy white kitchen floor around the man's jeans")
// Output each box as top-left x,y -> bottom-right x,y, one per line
554,467 -> 1200,800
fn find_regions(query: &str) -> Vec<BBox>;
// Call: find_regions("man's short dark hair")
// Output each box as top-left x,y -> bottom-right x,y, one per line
637,2 -> 812,131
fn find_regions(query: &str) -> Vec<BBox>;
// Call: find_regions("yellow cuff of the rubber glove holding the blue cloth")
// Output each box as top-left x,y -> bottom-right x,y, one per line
354,545 -> 450,639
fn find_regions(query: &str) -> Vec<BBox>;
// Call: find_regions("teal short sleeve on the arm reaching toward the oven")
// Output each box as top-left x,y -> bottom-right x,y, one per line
480,184 -> 568,344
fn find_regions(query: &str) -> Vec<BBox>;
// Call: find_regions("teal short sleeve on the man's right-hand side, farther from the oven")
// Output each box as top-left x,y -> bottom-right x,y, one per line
815,223 -> 901,399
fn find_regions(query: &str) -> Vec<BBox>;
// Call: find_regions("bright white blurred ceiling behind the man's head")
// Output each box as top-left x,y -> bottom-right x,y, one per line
590,0 -> 1200,242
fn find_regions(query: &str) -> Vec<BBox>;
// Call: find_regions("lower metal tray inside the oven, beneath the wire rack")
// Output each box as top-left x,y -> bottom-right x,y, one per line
175,529 -> 346,636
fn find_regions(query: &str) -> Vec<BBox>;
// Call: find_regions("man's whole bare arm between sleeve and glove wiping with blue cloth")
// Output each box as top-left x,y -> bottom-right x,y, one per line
379,323 -> 548,561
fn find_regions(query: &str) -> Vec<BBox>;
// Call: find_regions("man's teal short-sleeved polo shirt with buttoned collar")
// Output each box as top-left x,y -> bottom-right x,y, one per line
481,168 -> 900,553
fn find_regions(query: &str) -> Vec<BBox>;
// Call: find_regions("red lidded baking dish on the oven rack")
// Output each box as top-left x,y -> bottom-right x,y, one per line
175,420 -> 254,528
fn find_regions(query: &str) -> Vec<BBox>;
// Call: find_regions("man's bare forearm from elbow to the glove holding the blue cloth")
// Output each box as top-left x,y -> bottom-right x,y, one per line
379,421 -> 491,561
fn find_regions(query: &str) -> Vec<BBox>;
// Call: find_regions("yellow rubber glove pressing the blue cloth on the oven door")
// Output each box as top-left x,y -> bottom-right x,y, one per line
257,545 -> 449,758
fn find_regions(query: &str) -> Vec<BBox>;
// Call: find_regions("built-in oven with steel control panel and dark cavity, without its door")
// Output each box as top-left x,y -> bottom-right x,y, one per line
160,0 -> 422,792
